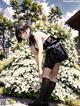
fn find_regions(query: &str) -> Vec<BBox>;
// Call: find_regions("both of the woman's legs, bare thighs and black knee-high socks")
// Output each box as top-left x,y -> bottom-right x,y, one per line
36,63 -> 60,102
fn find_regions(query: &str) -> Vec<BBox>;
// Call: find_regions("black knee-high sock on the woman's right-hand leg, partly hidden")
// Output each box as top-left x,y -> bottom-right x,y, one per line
45,81 -> 56,101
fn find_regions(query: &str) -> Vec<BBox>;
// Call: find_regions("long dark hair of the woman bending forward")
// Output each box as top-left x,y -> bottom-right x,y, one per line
15,24 -> 36,46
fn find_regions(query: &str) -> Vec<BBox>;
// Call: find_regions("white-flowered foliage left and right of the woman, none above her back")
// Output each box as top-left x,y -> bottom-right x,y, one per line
0,34 -> 80,100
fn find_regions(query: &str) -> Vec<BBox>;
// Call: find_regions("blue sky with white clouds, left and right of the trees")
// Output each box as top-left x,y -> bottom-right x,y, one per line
0,0 -> 80,36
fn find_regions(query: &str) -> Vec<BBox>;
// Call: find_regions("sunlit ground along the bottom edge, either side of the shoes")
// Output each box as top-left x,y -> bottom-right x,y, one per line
0,96 -> 67,106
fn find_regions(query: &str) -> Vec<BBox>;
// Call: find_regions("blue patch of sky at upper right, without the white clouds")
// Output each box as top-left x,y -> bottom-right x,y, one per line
46,0 -> 80,15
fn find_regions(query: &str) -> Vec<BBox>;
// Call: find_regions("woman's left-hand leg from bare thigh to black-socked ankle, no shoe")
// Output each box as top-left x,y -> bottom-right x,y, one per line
39,67 -> 52,102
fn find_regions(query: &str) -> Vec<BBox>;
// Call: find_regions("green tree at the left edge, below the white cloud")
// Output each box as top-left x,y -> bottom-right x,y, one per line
0,13 -> 13,55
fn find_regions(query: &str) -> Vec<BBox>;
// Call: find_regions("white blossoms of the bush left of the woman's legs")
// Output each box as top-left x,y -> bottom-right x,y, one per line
0,45 -> 39,93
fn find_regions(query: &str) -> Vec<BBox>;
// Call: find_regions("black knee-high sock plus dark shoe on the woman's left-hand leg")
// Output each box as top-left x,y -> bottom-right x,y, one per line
29,78 -> 50,106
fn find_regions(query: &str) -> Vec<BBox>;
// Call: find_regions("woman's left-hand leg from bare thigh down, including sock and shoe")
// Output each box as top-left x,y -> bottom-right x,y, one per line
29,67 -> 52,106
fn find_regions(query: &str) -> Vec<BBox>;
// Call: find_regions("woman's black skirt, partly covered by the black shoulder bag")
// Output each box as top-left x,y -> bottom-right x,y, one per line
43,36 -> 64,69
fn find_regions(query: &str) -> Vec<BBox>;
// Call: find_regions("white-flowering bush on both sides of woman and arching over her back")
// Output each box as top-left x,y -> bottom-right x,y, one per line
0,23 -> 80,101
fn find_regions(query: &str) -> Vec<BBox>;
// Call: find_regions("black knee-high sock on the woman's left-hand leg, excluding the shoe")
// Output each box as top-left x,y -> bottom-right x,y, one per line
39,78 -> 50,102
